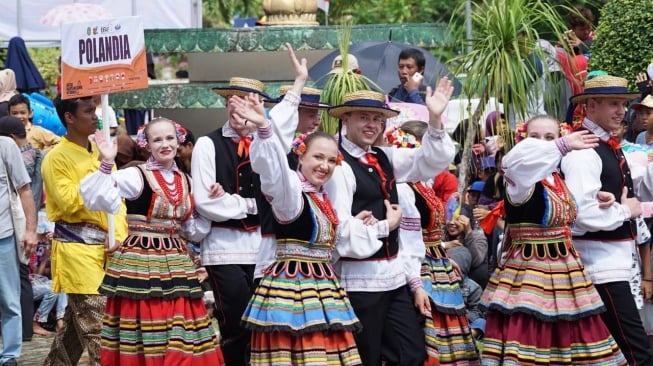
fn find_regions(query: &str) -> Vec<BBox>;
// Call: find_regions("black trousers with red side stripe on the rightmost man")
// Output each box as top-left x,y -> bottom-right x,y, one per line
595,281 -> 653,366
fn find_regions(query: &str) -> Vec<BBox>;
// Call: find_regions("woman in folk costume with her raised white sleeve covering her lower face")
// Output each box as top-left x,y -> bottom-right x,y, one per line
481,116 -> 626,365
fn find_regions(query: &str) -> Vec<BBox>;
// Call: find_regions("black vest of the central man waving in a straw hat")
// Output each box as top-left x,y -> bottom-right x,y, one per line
340,147 -> 399,260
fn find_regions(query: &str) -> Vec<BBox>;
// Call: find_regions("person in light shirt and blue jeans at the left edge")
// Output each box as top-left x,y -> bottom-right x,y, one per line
0,116 -> 37,365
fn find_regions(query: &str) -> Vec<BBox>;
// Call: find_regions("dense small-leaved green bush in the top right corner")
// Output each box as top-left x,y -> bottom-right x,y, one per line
589,0 -> 653,87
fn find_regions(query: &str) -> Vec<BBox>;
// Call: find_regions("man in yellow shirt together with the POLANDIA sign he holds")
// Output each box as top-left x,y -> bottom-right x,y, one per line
41,17 -> 148,365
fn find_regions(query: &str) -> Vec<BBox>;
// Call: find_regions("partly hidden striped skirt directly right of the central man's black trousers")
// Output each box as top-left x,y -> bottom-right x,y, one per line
421,247 -> 480,365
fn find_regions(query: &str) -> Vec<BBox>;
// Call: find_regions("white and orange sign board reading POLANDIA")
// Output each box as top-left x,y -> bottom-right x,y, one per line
61,17 -> 148,99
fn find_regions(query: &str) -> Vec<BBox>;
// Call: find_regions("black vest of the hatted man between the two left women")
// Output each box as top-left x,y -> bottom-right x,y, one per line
207,128 -> 274,234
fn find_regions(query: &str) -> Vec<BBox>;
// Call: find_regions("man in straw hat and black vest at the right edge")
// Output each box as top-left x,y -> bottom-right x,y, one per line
561,75 -> 653,365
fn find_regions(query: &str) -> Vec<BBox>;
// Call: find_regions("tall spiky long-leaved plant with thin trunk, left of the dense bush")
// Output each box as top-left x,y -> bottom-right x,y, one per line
453,0 -> 569,196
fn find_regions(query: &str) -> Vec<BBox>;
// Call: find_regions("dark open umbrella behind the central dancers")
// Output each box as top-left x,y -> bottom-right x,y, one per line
308,41 -> 462,95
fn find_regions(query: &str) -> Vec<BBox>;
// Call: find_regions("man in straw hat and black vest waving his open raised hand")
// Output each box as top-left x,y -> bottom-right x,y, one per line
325,78 -> 454,365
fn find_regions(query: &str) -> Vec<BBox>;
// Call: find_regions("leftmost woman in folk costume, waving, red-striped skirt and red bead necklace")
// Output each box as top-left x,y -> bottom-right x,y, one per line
80,118 -> 222,366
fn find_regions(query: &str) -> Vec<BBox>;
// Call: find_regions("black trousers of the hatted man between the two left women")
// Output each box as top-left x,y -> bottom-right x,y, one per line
205,264 -> 255,366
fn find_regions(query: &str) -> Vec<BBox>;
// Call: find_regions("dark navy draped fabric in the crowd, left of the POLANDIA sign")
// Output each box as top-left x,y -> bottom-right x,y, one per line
5,37 -> 45,93
